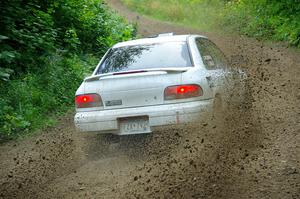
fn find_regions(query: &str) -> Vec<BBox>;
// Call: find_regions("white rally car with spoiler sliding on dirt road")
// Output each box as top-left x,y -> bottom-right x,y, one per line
74,33 -> 245,135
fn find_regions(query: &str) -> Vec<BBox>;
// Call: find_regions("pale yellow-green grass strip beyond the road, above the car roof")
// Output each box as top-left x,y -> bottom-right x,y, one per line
122,0 -> 224,31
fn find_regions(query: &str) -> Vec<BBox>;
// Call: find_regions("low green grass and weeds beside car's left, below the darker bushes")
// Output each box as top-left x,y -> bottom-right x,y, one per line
0,54 -> 99,141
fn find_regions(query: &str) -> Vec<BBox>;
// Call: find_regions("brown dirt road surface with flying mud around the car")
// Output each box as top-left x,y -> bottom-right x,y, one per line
0,0 -> 300,199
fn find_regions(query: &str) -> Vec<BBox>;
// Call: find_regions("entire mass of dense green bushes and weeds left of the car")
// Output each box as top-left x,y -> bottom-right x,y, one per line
0,0 -> 134,141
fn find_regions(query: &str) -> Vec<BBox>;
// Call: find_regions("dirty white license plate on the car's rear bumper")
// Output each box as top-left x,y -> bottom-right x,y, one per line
119,117 -> 151,135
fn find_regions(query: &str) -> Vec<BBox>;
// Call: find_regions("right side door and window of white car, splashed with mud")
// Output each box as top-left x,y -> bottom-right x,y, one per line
196,37 -> 227,95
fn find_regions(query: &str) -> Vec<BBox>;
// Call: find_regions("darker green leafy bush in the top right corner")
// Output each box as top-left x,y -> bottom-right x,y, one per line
223,0 -> 300,47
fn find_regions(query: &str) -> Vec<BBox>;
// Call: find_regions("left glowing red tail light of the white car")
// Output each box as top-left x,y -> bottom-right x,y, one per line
75,94 -> 103,108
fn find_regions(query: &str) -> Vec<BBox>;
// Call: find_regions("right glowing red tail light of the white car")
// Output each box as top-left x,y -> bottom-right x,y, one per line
164,84 -> 203,100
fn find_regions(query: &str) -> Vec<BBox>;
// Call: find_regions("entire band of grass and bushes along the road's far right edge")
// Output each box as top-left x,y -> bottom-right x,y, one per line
123,0 -> 300,47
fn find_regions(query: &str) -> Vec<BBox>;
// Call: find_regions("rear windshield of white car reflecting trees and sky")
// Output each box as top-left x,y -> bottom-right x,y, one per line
96,42 -> 192,74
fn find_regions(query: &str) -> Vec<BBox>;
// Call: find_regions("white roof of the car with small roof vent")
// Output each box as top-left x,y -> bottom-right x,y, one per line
113,33 -> 204,48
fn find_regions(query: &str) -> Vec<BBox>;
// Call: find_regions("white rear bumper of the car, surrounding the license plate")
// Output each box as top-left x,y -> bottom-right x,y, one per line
74,99 -> 213,134
